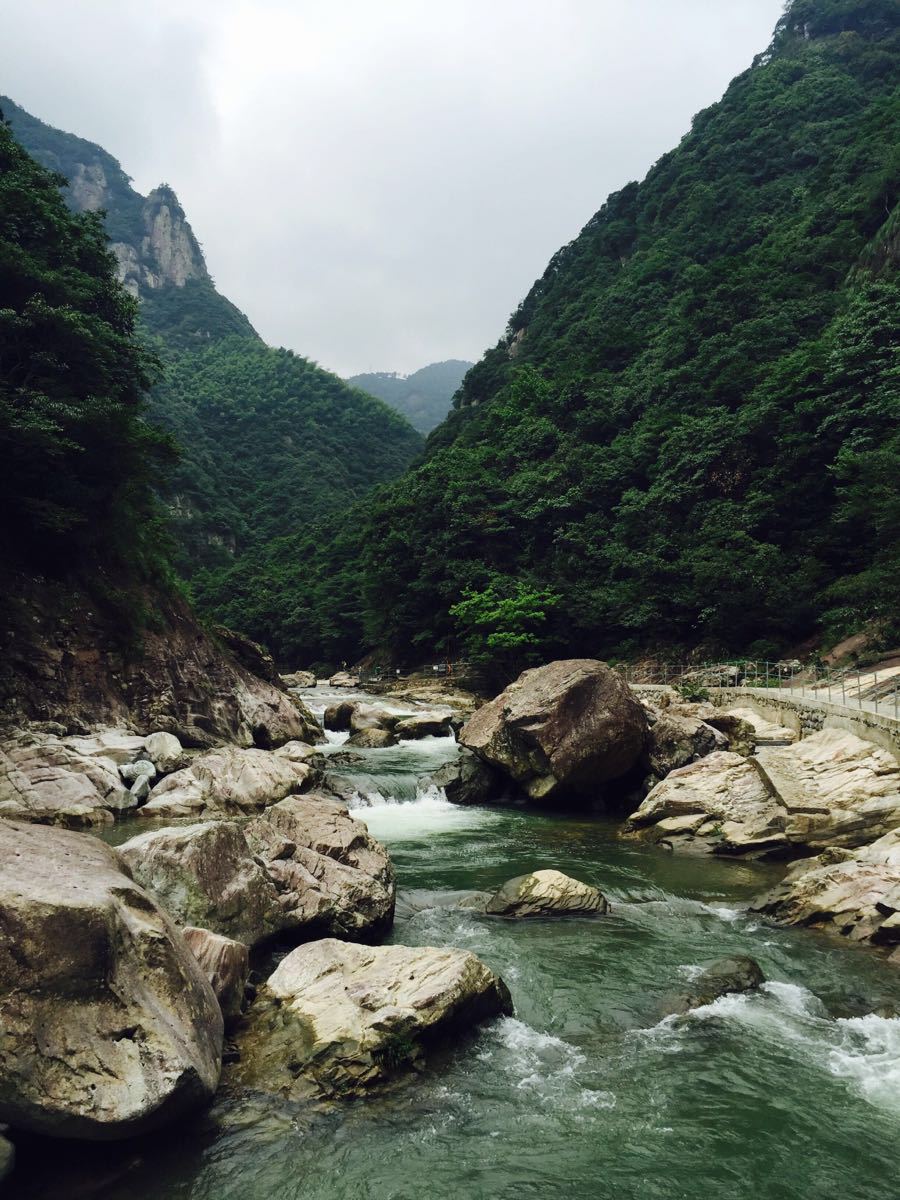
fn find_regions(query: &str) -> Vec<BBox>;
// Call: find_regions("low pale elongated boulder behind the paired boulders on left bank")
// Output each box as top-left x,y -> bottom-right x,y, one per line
140,746 -> 318,818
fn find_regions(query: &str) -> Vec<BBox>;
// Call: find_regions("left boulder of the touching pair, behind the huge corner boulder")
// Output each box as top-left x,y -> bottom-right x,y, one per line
119,821 -> 286,944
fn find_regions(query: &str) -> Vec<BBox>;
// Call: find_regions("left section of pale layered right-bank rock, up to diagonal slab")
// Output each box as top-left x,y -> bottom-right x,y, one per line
626,750 -> 788,856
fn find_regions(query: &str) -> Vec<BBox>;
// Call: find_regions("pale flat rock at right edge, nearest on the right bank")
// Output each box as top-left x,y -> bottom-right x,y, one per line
752,829 -> 900,946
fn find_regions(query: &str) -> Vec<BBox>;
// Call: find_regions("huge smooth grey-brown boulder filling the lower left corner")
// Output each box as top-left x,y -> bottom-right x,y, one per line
0,821 -> 222,1139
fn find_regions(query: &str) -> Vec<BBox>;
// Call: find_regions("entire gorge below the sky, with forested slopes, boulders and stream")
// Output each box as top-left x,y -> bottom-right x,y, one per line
0,0 -> 900,1200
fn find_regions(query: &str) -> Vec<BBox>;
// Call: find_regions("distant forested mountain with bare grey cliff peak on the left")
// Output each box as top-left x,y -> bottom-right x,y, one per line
0,97 -> 422,585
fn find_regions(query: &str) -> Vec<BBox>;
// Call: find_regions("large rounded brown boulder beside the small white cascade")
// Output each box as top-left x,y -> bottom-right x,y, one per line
460,659 -> 647,800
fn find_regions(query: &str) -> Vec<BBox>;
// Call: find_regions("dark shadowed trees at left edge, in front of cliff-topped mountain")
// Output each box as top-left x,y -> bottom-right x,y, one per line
0,115 -> 173,577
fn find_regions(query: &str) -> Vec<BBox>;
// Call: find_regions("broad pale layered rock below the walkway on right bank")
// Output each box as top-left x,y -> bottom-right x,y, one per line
629,730 -> 900,854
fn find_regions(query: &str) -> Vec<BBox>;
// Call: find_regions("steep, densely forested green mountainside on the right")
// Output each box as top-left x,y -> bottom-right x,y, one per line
220,0 -> 900,671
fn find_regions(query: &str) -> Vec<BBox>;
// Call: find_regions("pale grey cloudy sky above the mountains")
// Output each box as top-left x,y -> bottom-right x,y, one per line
0,0 -> 782,373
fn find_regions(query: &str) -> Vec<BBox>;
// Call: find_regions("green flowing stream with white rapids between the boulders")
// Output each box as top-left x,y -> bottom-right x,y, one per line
8,690 -> 900,1200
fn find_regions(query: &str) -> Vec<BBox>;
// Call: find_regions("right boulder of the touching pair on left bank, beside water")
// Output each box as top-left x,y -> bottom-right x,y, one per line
245,793 -> 396,941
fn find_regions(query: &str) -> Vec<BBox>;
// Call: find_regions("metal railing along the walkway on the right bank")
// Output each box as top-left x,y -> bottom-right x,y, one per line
618,659 -> 900,720
